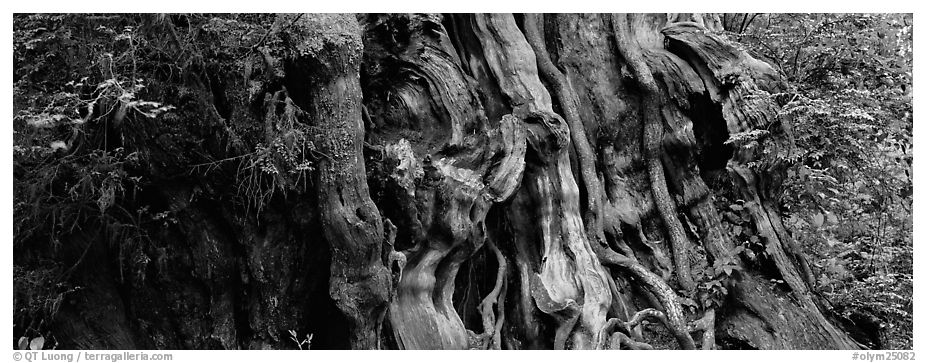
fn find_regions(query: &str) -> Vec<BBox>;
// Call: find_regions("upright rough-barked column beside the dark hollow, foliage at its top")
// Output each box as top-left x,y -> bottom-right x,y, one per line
275,14 -> 392,349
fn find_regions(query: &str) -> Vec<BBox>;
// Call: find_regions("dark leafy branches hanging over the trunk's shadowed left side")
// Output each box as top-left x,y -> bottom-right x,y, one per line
13,14 -> 334,346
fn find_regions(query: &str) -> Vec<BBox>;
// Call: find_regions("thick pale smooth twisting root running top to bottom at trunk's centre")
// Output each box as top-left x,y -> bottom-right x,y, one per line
472,14 -> 612,349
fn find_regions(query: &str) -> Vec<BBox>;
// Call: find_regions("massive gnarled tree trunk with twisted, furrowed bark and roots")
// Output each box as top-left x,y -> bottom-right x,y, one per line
30,14 -> 872,349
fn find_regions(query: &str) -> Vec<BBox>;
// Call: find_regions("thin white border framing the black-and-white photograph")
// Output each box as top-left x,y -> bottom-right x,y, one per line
0,4 -> 926,363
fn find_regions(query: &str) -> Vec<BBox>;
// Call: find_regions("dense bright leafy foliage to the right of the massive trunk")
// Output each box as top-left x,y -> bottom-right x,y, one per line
728,14 -> 913,349
